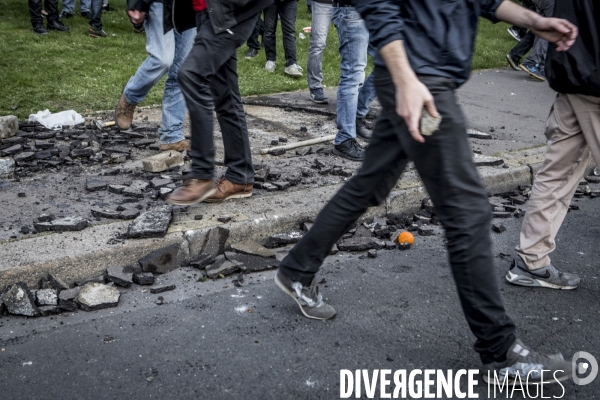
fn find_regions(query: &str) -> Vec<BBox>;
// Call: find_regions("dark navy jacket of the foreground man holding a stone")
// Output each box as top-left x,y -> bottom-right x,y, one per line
352,0 -> 504,86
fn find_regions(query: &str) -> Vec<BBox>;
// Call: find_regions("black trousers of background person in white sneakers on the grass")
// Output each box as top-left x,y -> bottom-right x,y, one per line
263,0 -> 298,67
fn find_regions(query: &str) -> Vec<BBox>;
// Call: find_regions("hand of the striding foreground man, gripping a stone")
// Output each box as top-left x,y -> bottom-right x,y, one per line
396,77 -> 439,143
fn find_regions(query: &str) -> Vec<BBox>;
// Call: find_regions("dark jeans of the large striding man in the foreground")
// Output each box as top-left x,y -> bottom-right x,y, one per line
279,67 -> 516,364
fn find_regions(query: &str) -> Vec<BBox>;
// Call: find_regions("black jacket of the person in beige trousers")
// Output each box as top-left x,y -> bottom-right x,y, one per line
546,0 -> 600,97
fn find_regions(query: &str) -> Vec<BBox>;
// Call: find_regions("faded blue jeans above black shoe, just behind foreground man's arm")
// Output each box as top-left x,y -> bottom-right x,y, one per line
333,7 -> 369,145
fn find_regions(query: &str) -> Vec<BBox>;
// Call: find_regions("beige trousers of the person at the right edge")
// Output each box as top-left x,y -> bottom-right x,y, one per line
517,94 -> 600,269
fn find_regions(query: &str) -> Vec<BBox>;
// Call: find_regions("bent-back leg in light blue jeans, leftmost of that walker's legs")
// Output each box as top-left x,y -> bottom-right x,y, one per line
123,0 -> 175,104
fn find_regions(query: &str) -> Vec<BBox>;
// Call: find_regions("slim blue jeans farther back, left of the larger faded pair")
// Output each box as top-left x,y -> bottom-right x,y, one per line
306,2 -> 333,90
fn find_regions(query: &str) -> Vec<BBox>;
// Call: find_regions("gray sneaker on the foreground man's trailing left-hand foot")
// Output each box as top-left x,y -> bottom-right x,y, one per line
275,270 -> 335,319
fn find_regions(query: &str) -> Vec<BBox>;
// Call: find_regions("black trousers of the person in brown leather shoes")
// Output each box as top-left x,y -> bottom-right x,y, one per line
177,12 -> 258,184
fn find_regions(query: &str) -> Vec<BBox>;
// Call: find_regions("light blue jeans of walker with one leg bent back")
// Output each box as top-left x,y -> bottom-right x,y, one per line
123,0 -> 196,144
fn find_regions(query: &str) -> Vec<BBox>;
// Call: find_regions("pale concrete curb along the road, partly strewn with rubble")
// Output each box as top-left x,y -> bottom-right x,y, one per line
0,147 -> 593,288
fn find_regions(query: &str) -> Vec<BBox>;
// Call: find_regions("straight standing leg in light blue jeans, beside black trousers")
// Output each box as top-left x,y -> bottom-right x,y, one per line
158,28 -> 196,147
